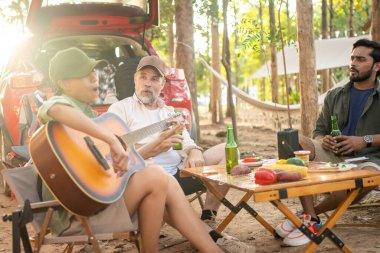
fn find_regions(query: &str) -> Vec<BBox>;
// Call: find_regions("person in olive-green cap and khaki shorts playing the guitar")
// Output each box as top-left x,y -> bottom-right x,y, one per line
38,48 -> 222,253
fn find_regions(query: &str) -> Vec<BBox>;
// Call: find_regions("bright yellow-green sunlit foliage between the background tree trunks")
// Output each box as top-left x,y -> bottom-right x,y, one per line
0,0 -> 378,103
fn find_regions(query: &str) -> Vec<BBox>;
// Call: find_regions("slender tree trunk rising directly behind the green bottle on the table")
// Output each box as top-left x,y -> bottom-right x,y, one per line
222,0 -> 238,142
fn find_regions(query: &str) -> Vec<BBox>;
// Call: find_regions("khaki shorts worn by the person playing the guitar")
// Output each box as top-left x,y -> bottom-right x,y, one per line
62,198 -> 138,236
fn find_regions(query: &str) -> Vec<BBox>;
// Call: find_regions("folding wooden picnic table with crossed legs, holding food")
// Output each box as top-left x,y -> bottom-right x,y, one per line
181,163 -> 380,252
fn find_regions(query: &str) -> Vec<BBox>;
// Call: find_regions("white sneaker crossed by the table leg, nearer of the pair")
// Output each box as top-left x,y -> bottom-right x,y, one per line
284,214 -> 322,246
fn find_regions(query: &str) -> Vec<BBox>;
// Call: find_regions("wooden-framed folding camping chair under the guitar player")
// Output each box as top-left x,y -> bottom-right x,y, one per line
1,166 -> 140,253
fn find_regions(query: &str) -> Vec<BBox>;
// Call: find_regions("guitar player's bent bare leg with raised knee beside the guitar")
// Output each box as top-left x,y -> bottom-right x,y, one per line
123,166 -> 168,253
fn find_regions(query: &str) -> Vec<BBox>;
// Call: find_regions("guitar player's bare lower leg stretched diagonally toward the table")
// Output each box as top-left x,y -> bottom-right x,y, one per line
166,176 -> 223,252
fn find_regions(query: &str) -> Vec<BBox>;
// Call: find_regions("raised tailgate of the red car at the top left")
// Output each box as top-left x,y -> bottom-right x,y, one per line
27,0 -> 159,35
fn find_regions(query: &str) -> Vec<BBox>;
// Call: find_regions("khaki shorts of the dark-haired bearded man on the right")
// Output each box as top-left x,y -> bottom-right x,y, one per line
311,140 -> 380,170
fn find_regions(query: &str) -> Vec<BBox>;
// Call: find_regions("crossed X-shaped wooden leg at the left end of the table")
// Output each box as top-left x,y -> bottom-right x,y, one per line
203,180 -> 277,236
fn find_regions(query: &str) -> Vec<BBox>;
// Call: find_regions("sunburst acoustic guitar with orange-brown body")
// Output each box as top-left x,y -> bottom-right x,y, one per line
30,113 -> 181,216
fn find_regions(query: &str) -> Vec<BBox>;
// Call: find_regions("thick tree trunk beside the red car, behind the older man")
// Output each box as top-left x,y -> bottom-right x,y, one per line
175,0 -> 200,141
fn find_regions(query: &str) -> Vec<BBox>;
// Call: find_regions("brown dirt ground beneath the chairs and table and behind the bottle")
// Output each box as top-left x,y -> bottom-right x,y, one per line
0,119 -> 380,253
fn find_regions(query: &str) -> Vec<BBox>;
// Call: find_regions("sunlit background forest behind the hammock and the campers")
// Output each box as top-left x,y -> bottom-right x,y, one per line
0,0 -> 380,139
